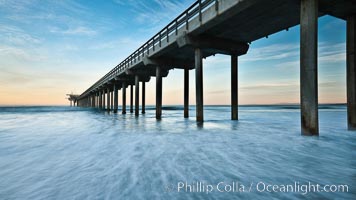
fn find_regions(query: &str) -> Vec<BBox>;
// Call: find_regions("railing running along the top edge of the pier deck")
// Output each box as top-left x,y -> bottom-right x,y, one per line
80,0 -> 219,97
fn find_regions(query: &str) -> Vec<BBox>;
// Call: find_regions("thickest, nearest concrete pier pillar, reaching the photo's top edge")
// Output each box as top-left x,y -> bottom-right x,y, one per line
300,0 -> 319,135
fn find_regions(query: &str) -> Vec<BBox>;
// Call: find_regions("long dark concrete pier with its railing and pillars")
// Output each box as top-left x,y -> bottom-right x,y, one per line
78,0 -> 356,135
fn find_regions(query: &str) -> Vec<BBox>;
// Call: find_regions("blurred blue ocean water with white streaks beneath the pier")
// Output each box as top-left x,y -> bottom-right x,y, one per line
0,105 -> 356,200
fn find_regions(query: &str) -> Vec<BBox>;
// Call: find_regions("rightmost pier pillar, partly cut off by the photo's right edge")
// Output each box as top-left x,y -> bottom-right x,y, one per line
346,15 -> 356,130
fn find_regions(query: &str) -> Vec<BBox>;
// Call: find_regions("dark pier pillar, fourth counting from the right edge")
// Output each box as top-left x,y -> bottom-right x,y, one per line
195,48 -> 204,122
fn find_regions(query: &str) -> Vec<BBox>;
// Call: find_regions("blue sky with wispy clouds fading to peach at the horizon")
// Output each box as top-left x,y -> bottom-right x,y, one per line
0,0 -> 346,105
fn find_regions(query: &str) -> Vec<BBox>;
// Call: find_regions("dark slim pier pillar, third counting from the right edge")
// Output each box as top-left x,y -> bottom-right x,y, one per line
231,55 -> 238,120
